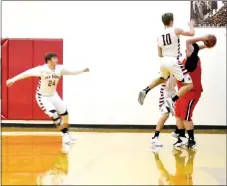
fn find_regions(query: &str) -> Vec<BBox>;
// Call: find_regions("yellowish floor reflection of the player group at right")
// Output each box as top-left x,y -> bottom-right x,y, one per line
154,149 -> 196,185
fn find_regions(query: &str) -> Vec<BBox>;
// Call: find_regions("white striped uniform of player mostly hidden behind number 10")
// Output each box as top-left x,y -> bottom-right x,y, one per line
159,75 -> 177,114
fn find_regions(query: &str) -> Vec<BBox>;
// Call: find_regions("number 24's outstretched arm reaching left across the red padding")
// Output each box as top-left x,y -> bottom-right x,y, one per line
6,67 -> 41,87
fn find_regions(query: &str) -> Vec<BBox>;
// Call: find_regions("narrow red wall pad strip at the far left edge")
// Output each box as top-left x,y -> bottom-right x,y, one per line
1,39 -> 8,119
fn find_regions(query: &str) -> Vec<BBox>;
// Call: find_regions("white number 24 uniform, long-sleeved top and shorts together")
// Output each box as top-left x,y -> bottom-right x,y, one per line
12,65 -> 82,117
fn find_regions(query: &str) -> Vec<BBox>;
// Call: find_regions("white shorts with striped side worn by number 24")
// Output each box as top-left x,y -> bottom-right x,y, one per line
36,94 -> 67,117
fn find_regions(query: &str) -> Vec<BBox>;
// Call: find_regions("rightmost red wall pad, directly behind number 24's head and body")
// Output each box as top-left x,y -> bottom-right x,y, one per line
32,39 -> 63,120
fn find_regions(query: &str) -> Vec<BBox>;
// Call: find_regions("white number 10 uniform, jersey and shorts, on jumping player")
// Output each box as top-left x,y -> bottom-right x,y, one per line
158,27 -> 192,83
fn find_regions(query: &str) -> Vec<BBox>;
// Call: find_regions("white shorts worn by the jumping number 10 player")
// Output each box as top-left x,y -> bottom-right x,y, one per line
160,56 -> 192,83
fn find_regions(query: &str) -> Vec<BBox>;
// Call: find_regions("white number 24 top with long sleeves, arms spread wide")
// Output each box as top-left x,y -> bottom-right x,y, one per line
12,65 -> 83,96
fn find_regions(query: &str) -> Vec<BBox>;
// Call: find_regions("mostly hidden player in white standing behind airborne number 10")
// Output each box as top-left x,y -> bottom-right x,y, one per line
151,75 -> 177,147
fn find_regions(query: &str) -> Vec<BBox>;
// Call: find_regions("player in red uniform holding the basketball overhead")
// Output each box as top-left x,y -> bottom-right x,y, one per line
174,36 -> 211,148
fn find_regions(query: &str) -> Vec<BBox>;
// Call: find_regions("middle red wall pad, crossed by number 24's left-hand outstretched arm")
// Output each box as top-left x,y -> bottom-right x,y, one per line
7,39 -> 33,120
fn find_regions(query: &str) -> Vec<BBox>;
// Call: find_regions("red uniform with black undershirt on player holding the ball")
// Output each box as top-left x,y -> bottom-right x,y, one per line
175,44 -> 203,121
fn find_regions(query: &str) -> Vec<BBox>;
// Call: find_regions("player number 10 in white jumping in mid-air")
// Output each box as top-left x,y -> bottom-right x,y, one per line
138,13 -> 195,115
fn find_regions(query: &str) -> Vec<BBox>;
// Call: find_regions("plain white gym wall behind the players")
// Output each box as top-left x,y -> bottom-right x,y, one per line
2,1 -> 226,126
